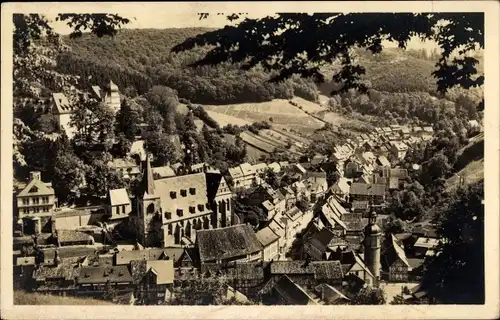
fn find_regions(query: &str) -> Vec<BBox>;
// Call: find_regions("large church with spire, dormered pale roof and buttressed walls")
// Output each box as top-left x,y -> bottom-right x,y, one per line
133,158 -> 233,247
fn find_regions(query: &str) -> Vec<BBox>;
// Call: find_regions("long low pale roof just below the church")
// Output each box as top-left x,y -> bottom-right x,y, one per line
116,247 -> 184,265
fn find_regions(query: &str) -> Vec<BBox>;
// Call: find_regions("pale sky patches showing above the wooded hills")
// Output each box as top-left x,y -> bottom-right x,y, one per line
47,10 -> 438,50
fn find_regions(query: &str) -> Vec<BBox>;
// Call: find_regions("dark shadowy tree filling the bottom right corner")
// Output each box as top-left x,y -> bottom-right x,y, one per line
422,181 -> 485,304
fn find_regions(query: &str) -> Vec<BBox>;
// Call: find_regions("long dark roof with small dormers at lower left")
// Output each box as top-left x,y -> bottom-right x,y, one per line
78,266 -> 133,284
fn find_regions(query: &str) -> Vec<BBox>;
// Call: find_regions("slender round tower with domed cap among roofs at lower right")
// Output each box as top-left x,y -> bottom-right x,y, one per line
363,212 -> 382,286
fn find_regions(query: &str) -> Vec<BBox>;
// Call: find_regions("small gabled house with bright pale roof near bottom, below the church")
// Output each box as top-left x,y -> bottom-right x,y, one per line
130,260 -> 174,304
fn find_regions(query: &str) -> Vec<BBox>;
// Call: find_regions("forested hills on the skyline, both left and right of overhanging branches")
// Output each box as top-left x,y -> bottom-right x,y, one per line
59,28 -> 484,104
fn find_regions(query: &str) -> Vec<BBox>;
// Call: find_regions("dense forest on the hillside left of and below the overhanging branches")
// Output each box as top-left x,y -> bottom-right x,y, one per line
58,28 -> 318,104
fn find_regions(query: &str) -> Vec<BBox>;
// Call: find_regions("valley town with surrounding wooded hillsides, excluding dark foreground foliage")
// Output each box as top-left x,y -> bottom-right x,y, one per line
12,13 -> 484,305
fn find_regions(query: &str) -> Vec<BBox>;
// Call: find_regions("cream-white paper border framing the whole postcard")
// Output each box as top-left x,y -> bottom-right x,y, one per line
0,1 -> 500,319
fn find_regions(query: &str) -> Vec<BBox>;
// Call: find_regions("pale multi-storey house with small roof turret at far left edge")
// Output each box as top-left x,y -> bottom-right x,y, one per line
16,171 -> 56,221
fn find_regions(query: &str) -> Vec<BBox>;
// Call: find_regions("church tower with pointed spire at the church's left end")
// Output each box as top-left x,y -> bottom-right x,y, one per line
136,155 -> 163,246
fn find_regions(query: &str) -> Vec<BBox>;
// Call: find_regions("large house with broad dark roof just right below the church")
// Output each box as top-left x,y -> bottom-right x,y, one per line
196,224 -> 263,264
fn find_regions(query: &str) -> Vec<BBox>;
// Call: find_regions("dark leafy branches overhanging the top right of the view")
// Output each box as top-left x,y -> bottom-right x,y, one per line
172,13 -> 484,110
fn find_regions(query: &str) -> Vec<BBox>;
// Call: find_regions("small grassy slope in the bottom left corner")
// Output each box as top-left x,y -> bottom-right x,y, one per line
14,290 -> 114,306
